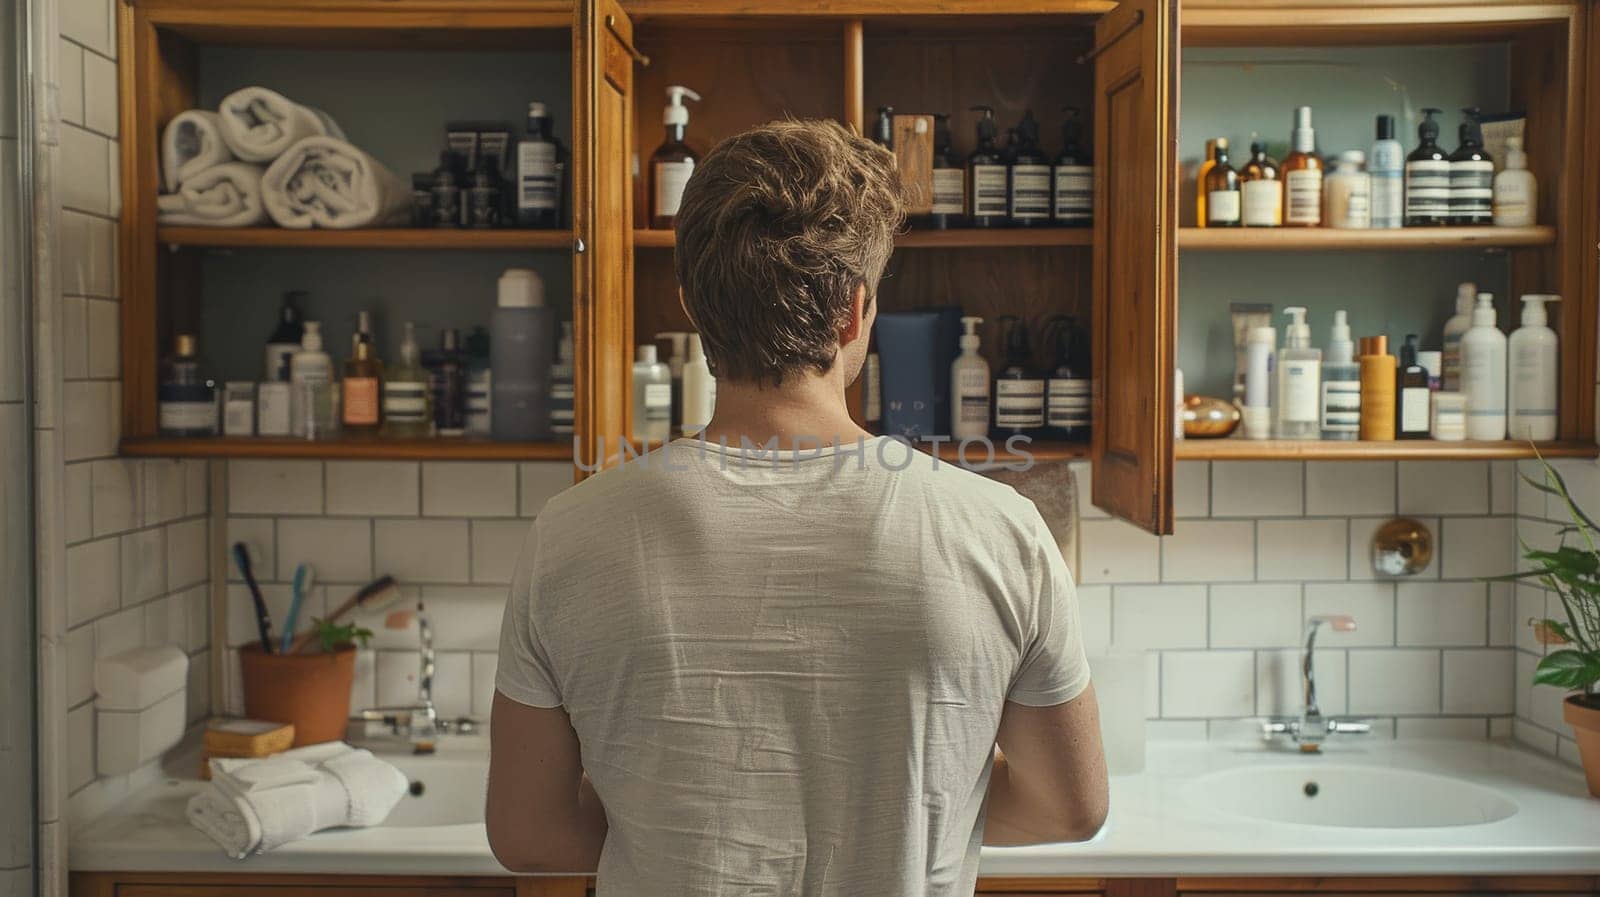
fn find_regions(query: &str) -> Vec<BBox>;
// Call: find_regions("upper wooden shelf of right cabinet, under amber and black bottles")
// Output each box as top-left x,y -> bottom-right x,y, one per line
1178,227 -> 1555,253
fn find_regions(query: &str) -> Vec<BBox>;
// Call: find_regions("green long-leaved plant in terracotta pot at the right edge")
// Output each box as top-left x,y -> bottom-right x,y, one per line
1494,457 -> 1600,798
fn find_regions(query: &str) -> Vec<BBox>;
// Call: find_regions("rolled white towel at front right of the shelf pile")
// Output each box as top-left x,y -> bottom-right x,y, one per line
261,138 -> 411,229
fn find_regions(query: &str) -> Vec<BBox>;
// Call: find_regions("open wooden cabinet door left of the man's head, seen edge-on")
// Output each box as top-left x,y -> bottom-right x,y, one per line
571,0 -> 637,476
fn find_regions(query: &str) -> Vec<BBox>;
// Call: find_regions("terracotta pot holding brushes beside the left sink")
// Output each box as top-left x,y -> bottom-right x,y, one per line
238,644 -> 355,747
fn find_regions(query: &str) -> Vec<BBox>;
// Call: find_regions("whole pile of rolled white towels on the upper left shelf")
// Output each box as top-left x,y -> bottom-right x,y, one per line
157,86 -> 411,229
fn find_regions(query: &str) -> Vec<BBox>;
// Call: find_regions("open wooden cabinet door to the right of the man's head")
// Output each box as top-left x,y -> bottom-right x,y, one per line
1093,0 -> 1178,532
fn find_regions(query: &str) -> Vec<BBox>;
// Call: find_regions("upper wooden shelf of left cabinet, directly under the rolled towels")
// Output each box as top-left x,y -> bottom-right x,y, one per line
155,227 -> 573,251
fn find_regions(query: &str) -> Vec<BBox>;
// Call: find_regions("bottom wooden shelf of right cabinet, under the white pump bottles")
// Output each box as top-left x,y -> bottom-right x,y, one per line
1176,438 -> 1600,460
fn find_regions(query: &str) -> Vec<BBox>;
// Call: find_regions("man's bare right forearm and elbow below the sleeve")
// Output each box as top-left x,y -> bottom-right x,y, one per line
984,684 -> 1110,846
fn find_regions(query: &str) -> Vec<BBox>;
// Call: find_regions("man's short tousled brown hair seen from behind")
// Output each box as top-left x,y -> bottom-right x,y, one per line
675,122 -> 904,385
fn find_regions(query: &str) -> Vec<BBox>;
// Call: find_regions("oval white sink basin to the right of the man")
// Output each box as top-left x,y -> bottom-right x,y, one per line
1187,763 -> 1517,828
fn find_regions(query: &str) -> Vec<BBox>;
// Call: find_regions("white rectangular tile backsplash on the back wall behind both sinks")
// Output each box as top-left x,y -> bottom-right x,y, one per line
227,450 -> 1600,767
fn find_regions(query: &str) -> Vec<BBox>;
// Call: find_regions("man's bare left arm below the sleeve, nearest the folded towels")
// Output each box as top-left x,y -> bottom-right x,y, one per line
485,692 -> 606,873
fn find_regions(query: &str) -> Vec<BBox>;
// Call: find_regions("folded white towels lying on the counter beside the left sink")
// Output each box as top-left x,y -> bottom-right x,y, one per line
187,742 -> 408,860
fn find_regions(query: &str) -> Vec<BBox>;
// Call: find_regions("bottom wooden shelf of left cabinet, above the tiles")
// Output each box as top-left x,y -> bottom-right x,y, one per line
122,437 -> 573,460
